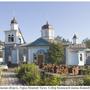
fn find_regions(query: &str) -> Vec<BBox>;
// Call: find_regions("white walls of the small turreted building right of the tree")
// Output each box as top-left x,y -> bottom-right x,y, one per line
66,48 -> 86,66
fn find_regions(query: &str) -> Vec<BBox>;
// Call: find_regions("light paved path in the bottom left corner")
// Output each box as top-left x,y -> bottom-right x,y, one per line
0,70 -> 22,86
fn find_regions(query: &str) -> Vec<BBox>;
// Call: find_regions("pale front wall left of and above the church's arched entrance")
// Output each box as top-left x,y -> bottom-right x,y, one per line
28,46 -> 49,63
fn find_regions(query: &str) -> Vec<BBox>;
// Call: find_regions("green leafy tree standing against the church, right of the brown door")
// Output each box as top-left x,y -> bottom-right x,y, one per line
48,43 -> 64,64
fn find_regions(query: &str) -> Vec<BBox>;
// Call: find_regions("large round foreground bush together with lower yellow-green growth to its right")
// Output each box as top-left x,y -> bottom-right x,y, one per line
16,64 -> 61,86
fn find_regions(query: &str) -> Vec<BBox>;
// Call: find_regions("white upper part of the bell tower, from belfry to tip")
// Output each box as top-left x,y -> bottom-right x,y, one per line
5,17 -> 25,44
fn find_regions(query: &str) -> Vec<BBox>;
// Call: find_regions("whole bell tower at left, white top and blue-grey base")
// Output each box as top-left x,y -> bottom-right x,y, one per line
5,17 -> 25,64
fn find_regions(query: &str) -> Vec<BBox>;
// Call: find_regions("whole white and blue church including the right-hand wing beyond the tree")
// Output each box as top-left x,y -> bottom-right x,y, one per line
1,17 -> 90,66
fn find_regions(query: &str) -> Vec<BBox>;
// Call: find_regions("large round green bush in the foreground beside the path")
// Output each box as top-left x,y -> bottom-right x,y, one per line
17,64 -> 40,85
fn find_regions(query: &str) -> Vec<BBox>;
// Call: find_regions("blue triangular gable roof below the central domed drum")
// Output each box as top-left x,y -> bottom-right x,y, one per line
27,38 -> 49,46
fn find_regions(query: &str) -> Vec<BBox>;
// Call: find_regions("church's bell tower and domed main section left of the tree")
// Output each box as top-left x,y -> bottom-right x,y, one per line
5,18 -> 54,65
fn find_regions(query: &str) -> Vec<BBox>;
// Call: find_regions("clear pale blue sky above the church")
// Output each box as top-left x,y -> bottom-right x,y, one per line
0,2 -> 90,42
